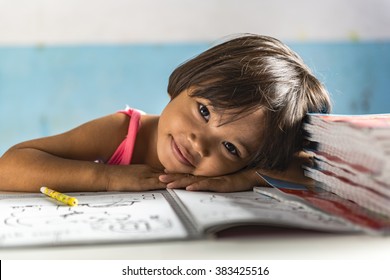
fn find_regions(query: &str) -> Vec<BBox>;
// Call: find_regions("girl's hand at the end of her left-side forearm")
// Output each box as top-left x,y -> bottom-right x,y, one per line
105,164 -> 166,191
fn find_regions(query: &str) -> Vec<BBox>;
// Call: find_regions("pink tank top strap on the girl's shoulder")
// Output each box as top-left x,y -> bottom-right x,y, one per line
107,108 -> 141,165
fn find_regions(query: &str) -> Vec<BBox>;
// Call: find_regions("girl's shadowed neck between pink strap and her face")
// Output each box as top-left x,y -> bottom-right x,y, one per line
131,115 -> 164,170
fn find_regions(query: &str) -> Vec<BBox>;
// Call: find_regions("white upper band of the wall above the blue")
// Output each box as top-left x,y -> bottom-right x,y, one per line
0,0 -> 390,45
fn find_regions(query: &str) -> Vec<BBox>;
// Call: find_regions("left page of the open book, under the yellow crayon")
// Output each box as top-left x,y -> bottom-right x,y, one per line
0,192 -> 187,247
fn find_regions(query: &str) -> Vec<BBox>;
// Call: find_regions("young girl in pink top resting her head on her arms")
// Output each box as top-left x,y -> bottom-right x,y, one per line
0,34 -> 330,192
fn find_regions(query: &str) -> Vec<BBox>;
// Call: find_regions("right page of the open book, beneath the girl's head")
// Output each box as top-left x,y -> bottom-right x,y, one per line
174,190 -> 357,232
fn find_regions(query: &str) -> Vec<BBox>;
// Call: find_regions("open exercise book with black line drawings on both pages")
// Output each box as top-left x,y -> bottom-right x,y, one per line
0,180 -> 388,248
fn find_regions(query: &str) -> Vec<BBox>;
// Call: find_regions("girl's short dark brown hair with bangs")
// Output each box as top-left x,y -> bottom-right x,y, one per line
168,34 -> 331,170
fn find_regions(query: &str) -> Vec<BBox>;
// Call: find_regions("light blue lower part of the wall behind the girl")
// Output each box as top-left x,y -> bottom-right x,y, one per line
0,42 -> 390,154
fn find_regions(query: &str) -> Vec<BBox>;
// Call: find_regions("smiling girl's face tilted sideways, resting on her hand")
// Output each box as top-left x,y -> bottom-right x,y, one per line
157,90 -> 264,176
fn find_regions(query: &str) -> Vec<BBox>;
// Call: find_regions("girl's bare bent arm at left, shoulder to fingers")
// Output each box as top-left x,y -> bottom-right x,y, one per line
0,113 -> 162,192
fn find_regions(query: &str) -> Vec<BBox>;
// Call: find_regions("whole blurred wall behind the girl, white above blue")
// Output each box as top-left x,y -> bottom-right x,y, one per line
0,0 -> 390,154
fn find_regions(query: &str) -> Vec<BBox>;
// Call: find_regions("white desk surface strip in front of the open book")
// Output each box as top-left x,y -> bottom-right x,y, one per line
0,232 -> 390,261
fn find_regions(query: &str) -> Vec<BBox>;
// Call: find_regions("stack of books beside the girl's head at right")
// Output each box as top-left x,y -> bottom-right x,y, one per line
303,114 -> 390,218
